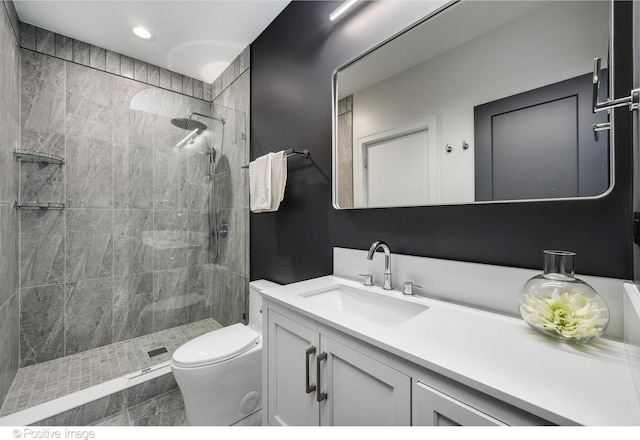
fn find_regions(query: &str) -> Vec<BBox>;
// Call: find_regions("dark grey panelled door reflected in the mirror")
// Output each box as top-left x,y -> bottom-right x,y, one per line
474,73 -> 609,201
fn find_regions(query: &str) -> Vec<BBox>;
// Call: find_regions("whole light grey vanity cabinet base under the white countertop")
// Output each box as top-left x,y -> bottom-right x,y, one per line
263,299 -> 549,426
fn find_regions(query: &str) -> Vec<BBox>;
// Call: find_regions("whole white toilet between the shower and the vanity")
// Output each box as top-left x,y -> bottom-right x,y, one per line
171,280 -> 279,426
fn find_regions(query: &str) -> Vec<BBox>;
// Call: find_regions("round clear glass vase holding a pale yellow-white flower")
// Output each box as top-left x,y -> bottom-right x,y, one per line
519,250 -> 609,343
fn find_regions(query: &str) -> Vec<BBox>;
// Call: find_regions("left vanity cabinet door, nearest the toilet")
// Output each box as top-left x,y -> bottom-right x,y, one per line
266,310 -> 320,426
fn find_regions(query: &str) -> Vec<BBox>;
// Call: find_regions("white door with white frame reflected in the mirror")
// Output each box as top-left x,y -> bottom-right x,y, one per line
354,115 -> 439,207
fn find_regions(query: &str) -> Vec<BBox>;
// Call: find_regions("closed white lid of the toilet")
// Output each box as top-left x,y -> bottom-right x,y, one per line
172,324 -> 260,368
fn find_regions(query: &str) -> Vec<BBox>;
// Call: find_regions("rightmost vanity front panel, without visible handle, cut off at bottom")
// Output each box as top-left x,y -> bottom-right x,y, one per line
413,382 -> 504,426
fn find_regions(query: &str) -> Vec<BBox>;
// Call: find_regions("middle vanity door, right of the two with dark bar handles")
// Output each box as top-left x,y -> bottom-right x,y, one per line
319,335 -> 411,426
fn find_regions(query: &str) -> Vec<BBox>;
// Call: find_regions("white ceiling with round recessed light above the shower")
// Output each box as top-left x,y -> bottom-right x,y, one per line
13,0 -> 290,83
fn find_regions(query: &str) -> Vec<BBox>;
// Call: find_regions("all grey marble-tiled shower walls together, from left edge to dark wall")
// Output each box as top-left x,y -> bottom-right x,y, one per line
0,2 -> 249,424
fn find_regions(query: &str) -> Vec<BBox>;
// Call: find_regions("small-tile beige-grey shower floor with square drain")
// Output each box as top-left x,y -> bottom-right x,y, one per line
0,318 -> 222,417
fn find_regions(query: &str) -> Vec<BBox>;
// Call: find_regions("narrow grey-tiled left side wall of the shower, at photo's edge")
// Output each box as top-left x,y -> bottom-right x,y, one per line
0,1 -> 20,402
